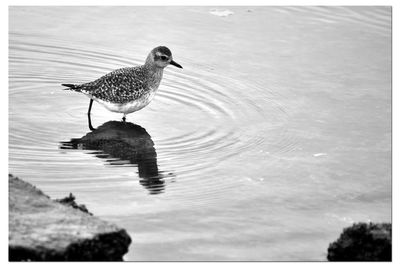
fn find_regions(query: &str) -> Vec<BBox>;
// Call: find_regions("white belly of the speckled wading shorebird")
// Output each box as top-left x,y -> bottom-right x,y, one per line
89,90 -> 156,114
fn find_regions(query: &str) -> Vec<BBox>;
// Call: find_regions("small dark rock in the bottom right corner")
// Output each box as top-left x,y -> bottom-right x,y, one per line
328,223 -> 392,261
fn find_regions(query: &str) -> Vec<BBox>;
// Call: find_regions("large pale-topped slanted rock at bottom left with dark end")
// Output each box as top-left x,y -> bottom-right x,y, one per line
9,175 -> 131,261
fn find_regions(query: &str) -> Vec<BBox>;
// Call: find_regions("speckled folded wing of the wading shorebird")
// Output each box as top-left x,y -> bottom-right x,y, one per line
80,67 -> 146,103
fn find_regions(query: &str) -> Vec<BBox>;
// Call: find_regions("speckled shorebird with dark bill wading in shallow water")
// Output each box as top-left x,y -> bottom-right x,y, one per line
61,46 -> 183,130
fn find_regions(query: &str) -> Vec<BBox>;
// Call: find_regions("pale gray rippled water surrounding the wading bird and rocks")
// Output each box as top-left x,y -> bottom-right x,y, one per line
9,7 -> 391,261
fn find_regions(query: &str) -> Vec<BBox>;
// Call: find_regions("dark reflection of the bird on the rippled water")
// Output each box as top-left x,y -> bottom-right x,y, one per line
60,121 -> 172,194
